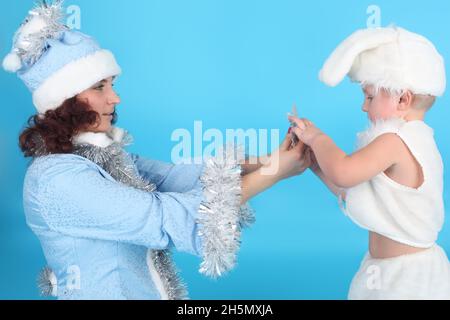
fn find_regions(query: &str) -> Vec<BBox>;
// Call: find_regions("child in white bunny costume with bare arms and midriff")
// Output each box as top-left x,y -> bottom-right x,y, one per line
289,27 -> 450,299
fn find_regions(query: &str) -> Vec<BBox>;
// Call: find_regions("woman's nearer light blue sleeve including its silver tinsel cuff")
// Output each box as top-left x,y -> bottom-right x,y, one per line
40,151 -> 254,277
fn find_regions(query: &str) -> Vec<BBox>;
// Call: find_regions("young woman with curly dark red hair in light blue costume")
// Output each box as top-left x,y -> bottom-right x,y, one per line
3,1 -> 309,299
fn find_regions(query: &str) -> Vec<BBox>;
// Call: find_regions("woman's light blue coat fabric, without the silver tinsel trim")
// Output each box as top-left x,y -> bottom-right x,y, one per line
24,154 -> 239,299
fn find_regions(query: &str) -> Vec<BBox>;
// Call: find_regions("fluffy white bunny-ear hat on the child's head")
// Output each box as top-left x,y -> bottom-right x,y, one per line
319,27 -> 446,96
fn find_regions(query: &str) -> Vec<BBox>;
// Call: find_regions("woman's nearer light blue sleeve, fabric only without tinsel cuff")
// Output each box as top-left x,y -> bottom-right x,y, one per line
38,158 -> 203,254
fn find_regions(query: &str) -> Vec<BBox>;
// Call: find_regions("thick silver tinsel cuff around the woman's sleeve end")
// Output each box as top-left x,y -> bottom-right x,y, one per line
198,145 -> 255,278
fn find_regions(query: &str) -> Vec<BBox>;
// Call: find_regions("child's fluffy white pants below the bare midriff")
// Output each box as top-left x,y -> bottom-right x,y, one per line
348,245 -> 450,300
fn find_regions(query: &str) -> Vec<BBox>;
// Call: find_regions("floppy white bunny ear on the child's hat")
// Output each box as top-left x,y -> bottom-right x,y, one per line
319,28 -> 397,87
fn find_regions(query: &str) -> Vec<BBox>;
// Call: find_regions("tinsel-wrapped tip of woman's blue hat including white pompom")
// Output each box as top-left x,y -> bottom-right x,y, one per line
3,0 -> 67,72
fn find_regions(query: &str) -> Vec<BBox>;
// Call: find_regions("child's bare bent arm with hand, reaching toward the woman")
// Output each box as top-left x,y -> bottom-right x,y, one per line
295,118 -> 405,188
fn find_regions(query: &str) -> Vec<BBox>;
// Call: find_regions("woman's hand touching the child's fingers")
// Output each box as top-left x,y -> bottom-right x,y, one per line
261,134 -> 311,182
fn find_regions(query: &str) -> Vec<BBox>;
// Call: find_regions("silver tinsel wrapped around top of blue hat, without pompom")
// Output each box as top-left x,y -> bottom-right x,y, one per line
13,0 -> 68,65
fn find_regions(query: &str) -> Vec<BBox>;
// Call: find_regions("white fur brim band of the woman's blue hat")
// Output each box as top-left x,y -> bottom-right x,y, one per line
33,50 -> 121,114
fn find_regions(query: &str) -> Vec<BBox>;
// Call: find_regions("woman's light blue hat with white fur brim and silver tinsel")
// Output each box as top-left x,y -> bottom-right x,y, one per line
3,1 -> 121,114
